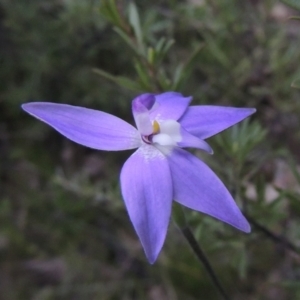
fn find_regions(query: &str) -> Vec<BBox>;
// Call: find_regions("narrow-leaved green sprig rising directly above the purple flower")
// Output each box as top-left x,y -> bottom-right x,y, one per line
95,0 -> 202,92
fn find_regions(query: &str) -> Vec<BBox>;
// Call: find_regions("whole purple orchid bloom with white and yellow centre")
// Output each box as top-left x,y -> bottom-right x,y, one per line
22,92 -> 255,263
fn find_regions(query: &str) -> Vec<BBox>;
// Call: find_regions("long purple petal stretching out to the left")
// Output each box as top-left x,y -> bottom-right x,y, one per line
22,102 -> 141,151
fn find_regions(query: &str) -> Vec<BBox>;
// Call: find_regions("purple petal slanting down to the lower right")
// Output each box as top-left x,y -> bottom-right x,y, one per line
167,148 -> 250,232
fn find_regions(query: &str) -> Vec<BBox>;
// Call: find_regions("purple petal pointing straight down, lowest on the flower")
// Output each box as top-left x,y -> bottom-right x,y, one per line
121,145 -> 172,264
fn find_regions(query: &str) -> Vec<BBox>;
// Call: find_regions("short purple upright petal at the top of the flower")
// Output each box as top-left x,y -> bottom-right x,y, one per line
150,92 -> 192,121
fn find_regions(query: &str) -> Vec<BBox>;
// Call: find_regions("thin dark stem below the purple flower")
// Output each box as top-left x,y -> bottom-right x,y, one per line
180,226 -> 229,300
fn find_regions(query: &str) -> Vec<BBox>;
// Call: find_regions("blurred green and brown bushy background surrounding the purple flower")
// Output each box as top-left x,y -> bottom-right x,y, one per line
0,0 -> 300,300
